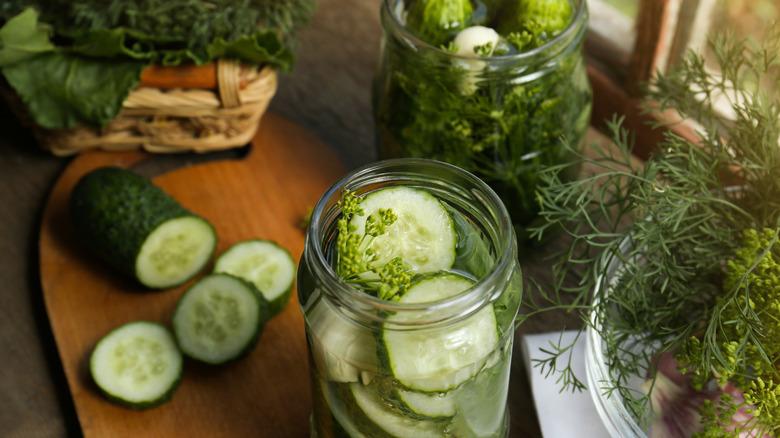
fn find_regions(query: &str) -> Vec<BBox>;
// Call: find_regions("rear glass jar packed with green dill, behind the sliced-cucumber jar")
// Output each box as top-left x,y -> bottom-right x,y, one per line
373,0 -> 592,251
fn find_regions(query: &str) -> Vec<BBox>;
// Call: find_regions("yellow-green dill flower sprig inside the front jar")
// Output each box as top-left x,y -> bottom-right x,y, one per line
336,190 -> 412,300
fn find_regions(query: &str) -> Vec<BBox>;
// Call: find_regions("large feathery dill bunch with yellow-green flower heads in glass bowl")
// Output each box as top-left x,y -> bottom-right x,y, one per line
524,28 -> 780,436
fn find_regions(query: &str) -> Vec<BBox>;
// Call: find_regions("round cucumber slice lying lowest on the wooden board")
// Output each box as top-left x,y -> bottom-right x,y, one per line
89,321 -> 182,410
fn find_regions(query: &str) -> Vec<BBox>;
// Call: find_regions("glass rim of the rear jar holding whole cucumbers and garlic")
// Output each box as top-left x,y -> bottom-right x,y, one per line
383,0 -> 588,62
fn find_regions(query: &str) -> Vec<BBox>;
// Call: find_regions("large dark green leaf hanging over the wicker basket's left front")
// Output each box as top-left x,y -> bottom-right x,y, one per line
2,52 -> 148,129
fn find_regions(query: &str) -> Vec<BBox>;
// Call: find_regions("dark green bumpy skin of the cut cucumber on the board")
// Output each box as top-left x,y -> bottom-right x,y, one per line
68,167 -> 216,287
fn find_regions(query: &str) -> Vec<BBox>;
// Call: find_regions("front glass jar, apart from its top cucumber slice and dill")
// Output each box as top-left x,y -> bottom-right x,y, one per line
297,159 -> 522,438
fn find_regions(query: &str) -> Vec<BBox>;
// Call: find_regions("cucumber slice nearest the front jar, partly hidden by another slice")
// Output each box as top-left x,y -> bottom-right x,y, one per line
214,239 -> 295,315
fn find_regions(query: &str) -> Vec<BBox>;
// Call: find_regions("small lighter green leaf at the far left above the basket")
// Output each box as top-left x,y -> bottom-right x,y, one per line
0,8 -> 54,66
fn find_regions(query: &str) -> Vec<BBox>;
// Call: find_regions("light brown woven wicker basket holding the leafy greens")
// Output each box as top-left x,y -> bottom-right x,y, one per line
6,59 -> 277,156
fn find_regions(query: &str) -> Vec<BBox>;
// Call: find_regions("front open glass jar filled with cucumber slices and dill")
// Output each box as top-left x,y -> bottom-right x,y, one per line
297,158 -> 522,438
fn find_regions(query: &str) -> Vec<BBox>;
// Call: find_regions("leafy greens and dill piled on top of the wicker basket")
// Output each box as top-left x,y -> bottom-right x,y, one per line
0,0 -> 315,129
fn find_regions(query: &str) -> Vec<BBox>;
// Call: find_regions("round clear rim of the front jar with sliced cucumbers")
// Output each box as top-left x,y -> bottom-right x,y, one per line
304,158 -> 517,326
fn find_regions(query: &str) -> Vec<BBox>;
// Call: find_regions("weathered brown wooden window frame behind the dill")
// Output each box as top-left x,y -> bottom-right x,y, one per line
585,0 -> 717,159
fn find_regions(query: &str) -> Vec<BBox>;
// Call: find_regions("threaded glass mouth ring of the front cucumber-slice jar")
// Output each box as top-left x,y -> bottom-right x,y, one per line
304,158 -> 517,326
